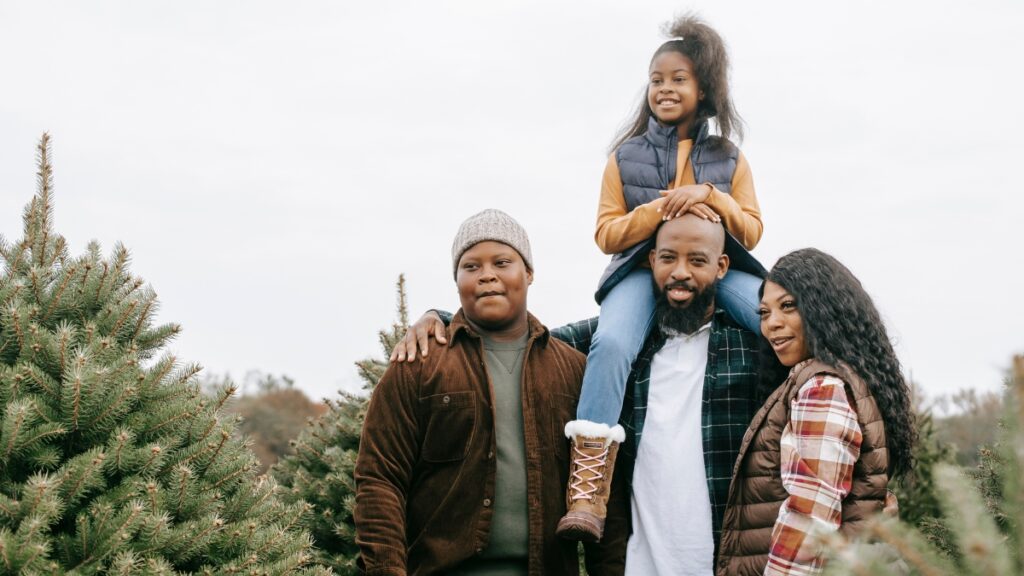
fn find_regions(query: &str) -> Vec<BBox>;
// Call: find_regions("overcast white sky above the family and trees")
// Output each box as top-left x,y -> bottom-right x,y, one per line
0,0 -> 1024,397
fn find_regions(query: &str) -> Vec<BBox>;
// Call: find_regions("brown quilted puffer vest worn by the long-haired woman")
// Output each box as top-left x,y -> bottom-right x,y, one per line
715,360 -> 889,576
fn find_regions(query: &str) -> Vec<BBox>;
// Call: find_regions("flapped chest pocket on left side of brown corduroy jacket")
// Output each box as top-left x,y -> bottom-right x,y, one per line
420,390 -> 476,462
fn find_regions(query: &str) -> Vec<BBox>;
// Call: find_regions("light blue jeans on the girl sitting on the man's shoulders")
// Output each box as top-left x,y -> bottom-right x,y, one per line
577,269 -> 761,426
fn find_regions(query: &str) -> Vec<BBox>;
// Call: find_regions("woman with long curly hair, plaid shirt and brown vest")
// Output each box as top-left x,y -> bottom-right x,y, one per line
716,248 -> 916,575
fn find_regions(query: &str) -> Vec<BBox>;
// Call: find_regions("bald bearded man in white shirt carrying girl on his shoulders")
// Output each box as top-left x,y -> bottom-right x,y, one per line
391,213 -> 765,576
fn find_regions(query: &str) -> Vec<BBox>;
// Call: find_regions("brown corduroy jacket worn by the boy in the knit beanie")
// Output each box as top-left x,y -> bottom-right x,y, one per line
354,311 -> 629,576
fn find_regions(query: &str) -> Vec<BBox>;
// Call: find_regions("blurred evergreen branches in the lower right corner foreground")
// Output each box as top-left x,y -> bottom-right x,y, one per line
824,357 -> 1024,576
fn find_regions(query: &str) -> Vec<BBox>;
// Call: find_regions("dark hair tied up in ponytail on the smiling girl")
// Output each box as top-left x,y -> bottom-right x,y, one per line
611,14 -> 743,150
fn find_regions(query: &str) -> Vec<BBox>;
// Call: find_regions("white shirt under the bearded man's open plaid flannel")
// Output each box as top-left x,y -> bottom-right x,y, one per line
626,324 -> 715,576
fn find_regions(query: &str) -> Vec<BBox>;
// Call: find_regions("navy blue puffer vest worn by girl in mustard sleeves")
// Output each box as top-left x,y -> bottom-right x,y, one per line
595,118 -> 766,303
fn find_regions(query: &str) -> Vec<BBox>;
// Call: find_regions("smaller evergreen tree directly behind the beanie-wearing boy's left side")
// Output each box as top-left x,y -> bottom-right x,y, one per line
274,276 -> 409,576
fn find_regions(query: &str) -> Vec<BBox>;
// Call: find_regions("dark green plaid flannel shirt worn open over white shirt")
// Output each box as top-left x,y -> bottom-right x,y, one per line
551,310 -> 760,550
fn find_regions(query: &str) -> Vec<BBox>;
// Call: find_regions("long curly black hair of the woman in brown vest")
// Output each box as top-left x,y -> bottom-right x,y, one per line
761,248 -> 918,476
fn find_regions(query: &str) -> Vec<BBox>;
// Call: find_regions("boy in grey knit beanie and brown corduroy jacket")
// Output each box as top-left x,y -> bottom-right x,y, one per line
354,210 -> 628,576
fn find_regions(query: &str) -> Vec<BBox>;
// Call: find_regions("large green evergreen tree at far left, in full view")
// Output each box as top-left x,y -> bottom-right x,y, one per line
0,134 -> 323,574
